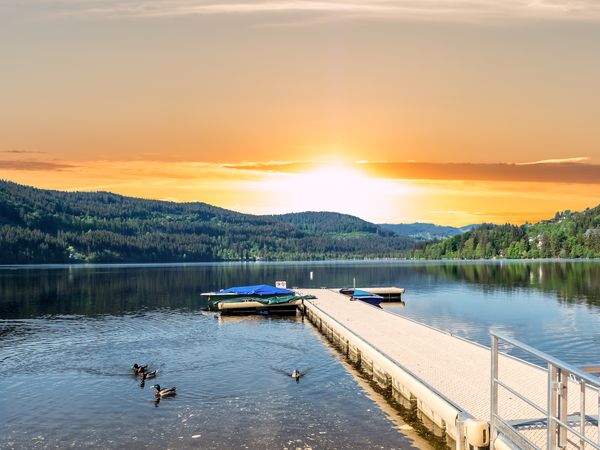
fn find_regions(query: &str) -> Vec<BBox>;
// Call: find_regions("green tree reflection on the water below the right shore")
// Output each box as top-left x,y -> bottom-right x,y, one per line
414,261 -> 600,306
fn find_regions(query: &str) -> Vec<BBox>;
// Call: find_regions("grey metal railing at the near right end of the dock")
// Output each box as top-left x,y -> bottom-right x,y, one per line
490,332 -> 600,450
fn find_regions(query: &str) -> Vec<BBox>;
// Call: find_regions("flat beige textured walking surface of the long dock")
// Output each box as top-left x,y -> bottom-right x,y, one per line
301,289 -> 599,448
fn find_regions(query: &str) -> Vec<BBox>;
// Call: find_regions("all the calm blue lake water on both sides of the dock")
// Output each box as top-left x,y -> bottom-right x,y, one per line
0,262 -> 600,449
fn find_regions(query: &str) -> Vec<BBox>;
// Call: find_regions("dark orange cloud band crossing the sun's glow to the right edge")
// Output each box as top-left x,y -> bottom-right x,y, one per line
226,158 -> 600,184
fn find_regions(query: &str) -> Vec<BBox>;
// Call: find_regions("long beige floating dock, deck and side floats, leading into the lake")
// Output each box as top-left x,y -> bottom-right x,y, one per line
298,288 -> 600,450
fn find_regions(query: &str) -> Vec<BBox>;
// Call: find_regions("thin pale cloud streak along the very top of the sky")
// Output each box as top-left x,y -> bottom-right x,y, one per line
19,0 -> 600,20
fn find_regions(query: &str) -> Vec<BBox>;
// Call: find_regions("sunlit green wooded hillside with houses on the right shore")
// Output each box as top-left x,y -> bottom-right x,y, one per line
408,206 -> 600,259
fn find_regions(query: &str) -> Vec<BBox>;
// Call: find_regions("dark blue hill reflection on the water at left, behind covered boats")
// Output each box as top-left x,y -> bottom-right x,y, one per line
0,263 -> 370,319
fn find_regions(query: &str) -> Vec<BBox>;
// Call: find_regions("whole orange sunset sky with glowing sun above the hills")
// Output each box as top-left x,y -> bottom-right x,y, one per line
0,0 -> 600,225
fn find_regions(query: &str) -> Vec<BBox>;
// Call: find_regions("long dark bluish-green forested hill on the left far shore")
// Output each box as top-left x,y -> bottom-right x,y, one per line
0,180 -> 412,264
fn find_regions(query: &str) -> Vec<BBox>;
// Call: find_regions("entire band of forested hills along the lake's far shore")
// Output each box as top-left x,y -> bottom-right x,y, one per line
0,180 -> 600,264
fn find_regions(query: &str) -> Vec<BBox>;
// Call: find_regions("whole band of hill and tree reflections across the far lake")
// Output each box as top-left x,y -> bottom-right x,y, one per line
0,261 -> 600,319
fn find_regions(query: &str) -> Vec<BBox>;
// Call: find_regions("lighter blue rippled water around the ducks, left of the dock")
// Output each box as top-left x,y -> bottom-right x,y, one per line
0,309 -> 418,448
